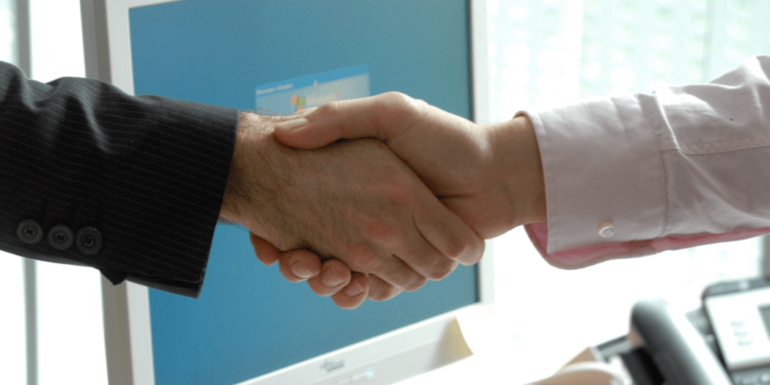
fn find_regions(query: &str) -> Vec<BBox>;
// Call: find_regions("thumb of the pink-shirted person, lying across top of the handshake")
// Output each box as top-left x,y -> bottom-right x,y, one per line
275,96 -> 394,150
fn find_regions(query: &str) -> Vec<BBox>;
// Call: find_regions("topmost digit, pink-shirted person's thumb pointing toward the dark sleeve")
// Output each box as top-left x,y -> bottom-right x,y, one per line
275,92 -> 415,149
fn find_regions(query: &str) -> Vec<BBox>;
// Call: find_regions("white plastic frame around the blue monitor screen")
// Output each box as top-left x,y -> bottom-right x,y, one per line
81,0 -> 494,385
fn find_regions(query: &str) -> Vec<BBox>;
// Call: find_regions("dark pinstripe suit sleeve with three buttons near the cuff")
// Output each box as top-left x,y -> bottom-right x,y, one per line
0,63 -> 238,297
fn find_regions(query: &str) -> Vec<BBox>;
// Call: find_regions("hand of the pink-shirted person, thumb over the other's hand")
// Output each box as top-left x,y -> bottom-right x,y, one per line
275,93 -> 546,239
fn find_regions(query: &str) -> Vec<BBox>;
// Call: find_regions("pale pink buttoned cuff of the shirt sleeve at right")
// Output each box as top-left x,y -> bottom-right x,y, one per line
517,95 -> 665,258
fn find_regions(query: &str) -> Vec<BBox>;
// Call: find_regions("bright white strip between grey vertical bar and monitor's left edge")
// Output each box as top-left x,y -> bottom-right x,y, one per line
30,0 -> 107,385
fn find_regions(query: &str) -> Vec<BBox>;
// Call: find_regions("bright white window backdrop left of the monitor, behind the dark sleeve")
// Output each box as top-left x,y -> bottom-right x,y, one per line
0,0 -> 107,385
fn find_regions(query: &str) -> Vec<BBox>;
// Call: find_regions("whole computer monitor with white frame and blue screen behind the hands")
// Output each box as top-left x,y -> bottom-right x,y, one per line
81,0 -> 493,385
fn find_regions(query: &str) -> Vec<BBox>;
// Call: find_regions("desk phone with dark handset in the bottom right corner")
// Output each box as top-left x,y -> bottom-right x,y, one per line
595,277 -> 770,385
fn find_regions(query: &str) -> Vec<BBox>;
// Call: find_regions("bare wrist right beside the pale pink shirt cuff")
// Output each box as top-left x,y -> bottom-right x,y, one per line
485,115 -> 548,228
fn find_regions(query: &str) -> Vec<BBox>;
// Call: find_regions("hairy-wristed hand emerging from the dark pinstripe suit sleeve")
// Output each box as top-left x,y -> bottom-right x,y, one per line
222,113 -> 483,307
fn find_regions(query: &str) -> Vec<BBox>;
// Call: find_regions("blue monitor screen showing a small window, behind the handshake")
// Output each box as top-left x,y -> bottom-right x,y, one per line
130,0 -> 477,385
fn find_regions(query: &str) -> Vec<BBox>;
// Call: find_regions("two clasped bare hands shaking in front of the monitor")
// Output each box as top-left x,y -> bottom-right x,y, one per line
220,93 -> 546,308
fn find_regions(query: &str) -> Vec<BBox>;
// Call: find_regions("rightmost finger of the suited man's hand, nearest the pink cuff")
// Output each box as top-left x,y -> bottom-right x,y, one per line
413,187 -> 484,267
